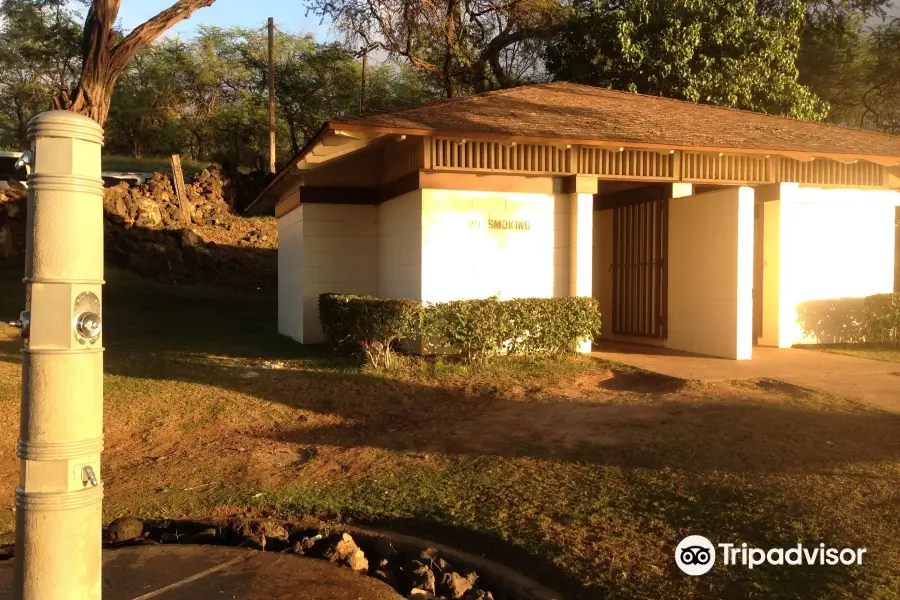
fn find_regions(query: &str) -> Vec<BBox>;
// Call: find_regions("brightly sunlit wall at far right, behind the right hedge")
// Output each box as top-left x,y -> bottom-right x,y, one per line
760,183 -> 900,347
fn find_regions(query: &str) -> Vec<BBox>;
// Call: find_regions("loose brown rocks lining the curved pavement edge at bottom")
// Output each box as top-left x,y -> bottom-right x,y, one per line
96,517 -> 511,600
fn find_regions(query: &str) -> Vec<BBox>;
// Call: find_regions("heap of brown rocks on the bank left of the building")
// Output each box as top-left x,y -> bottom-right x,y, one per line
0,169 -> 278,289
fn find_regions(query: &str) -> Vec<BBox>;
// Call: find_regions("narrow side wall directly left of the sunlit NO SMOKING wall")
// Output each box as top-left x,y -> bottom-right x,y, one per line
378,190 -> 422,300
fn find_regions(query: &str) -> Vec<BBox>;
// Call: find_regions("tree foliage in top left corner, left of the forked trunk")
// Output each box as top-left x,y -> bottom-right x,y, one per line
0,0 -> 81,148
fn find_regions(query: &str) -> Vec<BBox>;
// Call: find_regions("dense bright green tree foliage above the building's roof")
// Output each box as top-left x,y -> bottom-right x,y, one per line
547,0 -> 827,120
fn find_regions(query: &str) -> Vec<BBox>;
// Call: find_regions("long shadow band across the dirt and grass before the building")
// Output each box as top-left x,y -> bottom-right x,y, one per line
63,349 -> 900,474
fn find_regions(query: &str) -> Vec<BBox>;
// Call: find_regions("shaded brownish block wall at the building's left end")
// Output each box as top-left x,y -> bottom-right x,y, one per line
278,204 -> 378,344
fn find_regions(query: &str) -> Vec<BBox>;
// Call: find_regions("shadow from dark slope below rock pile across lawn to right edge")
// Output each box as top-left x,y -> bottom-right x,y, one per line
0,264 -> 900,473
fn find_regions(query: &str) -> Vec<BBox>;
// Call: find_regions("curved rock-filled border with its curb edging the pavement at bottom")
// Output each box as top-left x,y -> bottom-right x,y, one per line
7,517 -> 564,600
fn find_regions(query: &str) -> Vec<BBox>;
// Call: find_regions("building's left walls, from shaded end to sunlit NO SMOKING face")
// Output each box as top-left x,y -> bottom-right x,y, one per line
278,189 -> 594,350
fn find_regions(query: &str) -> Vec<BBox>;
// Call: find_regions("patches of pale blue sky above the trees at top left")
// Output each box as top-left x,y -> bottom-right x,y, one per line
119,0 -> 336,41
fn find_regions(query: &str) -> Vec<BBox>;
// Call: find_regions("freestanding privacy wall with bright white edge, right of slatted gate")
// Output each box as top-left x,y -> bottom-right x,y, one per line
666,188 -> 754,360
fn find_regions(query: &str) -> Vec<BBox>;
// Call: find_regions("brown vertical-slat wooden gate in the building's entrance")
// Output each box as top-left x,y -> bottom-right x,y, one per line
612,197 -> 669,338
